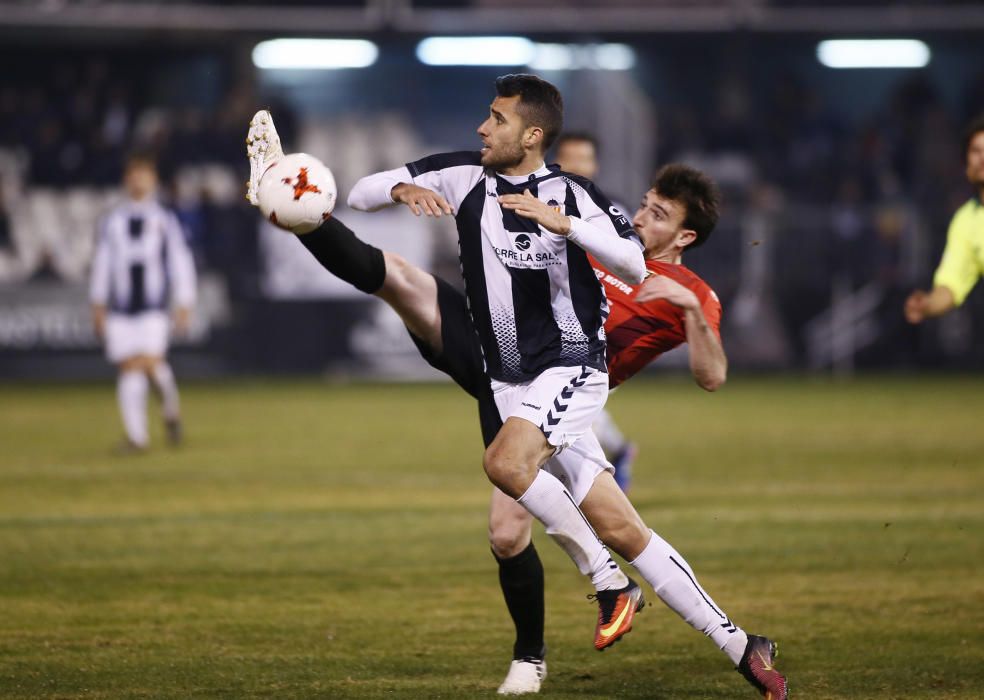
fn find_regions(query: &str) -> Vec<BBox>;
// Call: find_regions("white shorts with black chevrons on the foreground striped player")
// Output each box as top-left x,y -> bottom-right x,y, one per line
492,366 -> 608,453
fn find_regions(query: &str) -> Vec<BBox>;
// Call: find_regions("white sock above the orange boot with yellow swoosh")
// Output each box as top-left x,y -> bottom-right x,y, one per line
517,469 -> 629,591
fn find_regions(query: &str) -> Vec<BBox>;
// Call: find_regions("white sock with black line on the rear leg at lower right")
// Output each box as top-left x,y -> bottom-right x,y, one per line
630,532 -> 748,666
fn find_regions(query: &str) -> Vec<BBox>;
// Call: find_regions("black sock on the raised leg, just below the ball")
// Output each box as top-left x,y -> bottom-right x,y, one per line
297,217 -> 386,294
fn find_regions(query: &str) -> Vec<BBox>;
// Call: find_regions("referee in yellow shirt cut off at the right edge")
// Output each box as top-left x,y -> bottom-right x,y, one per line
905,115 -> 984,323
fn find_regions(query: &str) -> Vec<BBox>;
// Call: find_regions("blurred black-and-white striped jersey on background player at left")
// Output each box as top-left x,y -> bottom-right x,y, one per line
89,201 -> 195,314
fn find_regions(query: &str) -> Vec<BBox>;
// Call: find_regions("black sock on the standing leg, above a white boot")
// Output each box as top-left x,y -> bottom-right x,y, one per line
492,542 -> 547,659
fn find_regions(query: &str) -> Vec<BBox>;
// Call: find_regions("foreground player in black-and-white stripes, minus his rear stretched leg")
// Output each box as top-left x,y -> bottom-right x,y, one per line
348,75 -> 645,647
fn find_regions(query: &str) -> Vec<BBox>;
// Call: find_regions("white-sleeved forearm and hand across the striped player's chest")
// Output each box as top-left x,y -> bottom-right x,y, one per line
499,190 -> 646,284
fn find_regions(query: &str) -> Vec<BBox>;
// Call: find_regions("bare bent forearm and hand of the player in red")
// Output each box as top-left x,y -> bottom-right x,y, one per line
636,275 -> 728,391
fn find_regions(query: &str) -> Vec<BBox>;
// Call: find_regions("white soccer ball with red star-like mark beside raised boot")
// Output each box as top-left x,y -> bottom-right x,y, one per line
256,153 -> 338,234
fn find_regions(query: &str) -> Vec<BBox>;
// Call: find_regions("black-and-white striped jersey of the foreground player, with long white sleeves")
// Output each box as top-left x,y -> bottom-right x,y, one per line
349,151 -> 645,383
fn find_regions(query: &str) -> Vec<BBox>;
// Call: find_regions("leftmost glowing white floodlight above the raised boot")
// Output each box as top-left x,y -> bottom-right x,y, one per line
253,39 -> 379,70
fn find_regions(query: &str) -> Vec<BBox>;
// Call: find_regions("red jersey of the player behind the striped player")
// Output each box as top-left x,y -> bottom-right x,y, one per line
589,256 -> 721,388
